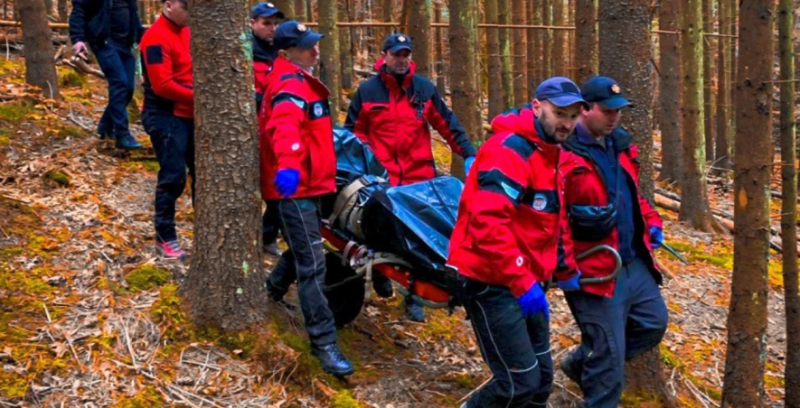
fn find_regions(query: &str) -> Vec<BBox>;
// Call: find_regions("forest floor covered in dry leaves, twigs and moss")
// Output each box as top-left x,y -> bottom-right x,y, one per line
0,57 -> 785,408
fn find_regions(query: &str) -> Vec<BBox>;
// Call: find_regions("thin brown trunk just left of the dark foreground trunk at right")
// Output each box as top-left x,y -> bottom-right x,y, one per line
714,0 -> 735,169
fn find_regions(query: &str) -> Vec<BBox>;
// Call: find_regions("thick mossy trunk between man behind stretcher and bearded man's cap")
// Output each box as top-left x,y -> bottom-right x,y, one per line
449,0 -> 483,179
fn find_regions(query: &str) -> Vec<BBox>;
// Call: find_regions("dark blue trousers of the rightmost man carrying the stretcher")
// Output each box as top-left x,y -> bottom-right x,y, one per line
566,257 -> 667,408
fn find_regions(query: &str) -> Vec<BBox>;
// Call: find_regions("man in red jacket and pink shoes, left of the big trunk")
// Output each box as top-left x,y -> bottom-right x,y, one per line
139,0 -> 194,259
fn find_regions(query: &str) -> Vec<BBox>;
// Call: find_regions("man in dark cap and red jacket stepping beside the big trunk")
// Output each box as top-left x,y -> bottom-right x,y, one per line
259,21 -> 353,376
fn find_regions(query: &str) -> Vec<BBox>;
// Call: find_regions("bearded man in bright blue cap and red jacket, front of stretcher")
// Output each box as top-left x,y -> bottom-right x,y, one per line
448,77 -> 586,408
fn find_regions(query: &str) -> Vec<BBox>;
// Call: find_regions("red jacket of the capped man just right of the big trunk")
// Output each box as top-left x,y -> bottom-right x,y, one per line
258,57 -> 336,200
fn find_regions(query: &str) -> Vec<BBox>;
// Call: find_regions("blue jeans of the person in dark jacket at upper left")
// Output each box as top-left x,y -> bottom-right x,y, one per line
92,39 -> 135,138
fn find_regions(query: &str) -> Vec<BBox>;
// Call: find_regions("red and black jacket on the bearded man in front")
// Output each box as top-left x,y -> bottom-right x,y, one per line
448,109 -> 575,297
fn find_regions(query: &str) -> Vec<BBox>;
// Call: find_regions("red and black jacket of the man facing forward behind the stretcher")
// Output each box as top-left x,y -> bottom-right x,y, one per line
344,59 -> 475,185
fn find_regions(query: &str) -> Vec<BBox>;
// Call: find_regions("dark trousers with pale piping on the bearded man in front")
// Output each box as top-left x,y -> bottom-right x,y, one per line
460,276 -> 553,408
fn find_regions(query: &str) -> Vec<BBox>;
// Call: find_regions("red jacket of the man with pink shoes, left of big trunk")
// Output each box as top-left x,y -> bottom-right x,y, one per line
139,15 -> 194,118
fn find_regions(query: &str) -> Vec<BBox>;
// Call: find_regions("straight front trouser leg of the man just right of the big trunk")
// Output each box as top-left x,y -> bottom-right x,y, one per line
278,198 -> 336,346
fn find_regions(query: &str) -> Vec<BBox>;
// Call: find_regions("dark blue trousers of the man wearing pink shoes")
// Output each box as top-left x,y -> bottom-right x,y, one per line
142,112 -> 195,242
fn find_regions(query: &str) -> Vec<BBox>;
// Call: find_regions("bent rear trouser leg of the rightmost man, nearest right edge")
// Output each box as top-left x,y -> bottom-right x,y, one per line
625,258 -> 669,360
